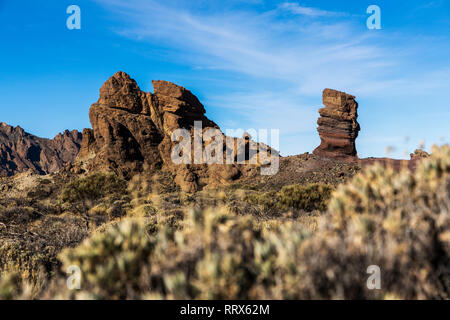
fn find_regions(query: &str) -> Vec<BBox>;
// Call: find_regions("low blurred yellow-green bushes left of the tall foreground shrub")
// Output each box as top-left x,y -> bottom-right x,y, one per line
53,209 -> 305,299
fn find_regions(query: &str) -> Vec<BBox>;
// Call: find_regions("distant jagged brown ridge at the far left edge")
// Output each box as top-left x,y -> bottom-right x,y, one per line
0,122 -> 82,176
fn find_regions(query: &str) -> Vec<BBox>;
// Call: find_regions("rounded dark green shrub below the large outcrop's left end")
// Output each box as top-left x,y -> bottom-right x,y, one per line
61,173 -> 127,203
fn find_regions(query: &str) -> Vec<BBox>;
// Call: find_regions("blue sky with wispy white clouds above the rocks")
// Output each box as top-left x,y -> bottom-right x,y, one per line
0,0 -> 450,158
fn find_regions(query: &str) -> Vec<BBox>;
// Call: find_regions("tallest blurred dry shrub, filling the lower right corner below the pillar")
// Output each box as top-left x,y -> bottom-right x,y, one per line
302,146 -> 450,299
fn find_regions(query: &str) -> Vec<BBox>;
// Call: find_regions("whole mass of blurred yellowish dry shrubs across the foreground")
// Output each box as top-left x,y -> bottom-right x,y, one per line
4,147 -> 450,299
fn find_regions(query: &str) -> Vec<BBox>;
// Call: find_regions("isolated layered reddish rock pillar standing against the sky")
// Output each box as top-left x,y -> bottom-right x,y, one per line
314,89 -> 360,160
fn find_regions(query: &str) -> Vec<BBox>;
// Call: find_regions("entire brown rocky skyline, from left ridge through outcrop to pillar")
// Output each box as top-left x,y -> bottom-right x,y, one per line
0,71 -> 426,186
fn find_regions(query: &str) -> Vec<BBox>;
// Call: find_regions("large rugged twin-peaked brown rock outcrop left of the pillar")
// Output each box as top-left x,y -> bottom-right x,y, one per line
77,72 -> 274,192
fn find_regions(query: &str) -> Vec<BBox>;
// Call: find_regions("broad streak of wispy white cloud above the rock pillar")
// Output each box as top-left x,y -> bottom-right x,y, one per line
96,0 -> 394,95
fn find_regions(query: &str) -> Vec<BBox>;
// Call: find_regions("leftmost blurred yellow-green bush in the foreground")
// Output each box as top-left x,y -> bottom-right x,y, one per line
61,219 -> 152,299
